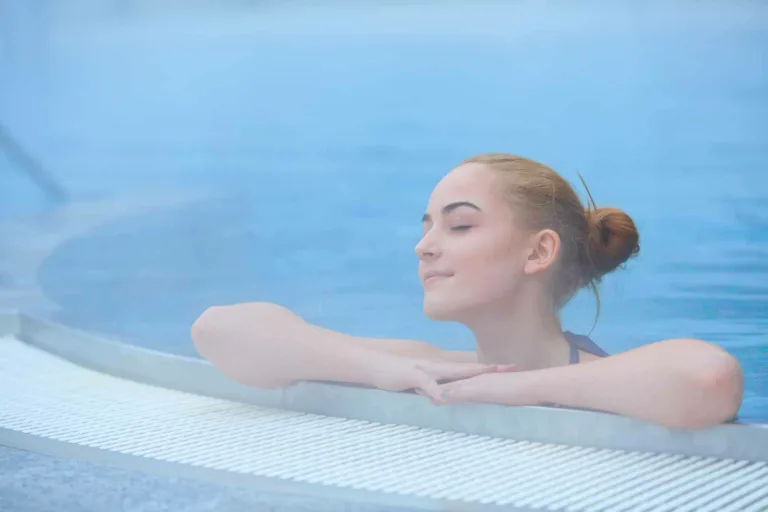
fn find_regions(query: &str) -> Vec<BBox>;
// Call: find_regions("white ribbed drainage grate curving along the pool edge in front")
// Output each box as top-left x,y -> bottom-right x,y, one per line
0,338 -> 768,511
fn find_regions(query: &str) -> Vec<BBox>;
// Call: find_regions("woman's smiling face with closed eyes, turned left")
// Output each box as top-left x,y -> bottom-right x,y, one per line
416,163 -> 528,322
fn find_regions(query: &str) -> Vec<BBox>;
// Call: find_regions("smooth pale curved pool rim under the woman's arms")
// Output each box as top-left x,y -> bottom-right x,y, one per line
0,311 -> 768,461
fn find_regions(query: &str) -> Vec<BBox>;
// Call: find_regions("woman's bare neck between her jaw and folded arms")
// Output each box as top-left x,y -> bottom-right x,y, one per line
465,288 -> 570,371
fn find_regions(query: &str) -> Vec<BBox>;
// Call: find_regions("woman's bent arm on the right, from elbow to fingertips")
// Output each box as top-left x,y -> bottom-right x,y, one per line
442,339 -> 743,428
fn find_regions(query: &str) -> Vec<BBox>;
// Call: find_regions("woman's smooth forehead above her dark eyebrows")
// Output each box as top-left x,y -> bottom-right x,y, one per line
428,163 -> 501,210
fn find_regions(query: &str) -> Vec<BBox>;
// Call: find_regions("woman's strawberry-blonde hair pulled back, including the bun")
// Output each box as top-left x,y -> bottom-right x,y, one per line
462,153 -> 640,314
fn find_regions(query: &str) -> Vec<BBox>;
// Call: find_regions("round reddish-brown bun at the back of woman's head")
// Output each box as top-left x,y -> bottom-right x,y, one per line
586,208 -> 640,279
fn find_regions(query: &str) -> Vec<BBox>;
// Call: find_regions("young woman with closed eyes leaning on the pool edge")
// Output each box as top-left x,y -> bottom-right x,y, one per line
192,154 -> 743,428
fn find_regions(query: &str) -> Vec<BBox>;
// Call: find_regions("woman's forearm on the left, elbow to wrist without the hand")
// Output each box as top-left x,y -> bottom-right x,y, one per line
191,303 -> 386,388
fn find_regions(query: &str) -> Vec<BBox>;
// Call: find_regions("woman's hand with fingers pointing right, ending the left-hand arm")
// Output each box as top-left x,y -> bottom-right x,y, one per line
373,356 -> 514,401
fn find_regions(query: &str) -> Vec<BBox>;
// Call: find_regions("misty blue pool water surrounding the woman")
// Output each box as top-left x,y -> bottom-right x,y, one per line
0,0 -> 768,422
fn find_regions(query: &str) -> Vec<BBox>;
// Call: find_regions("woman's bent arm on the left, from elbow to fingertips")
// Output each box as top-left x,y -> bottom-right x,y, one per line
191,303 -> 484,391
